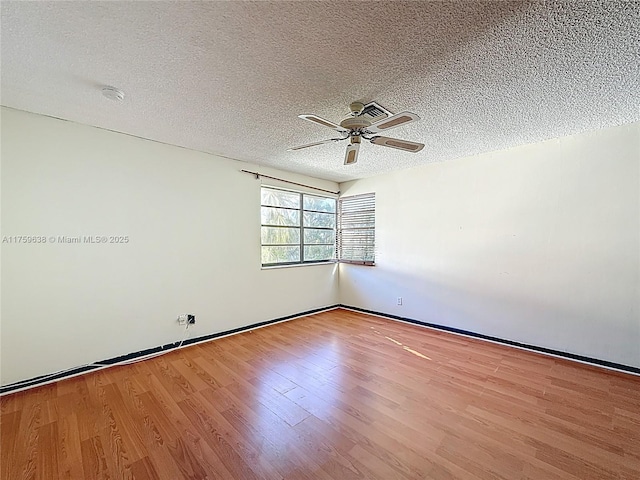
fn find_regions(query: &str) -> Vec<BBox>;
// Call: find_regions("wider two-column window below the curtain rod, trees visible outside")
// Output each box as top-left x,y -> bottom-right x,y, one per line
261,187 -> 336,266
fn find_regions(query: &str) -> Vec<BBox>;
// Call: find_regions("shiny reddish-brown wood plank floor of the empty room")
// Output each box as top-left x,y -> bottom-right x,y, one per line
0,310 -> 640,480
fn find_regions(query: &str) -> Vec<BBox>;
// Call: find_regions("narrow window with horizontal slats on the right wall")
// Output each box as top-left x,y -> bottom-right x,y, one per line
337,193 -> 376,265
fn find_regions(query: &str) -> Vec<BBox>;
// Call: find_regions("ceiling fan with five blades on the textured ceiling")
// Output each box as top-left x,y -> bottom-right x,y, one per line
288,102 -> 424,165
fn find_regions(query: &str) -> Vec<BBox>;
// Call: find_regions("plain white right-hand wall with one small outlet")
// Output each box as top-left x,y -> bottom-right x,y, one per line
340,124 -> 640,367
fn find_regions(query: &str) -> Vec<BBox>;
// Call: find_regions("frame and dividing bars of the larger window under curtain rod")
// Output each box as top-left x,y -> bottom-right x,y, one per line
260,185 -> 338,268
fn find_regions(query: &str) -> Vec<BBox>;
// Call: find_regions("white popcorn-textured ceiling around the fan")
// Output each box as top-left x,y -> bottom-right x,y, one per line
0,1 -> 640,181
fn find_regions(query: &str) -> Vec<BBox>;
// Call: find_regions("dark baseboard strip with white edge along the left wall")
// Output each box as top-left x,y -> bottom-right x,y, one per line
0,305 -> 339,395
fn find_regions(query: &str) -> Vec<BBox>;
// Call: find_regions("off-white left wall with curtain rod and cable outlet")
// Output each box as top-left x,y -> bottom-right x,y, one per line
1,108 -> 338,385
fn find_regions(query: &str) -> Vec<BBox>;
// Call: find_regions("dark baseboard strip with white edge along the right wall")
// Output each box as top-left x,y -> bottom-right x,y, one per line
338,304 -> 640,375
